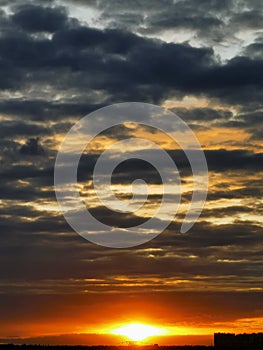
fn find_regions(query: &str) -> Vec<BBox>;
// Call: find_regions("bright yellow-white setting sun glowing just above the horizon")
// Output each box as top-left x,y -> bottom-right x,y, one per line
110,323 -> 166,341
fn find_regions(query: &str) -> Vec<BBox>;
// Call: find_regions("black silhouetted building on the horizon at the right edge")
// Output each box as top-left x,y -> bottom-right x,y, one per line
214,333 -> 263,350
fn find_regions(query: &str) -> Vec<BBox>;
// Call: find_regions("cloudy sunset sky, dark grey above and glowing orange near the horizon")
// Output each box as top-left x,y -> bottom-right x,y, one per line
0,0 -> 263,343
